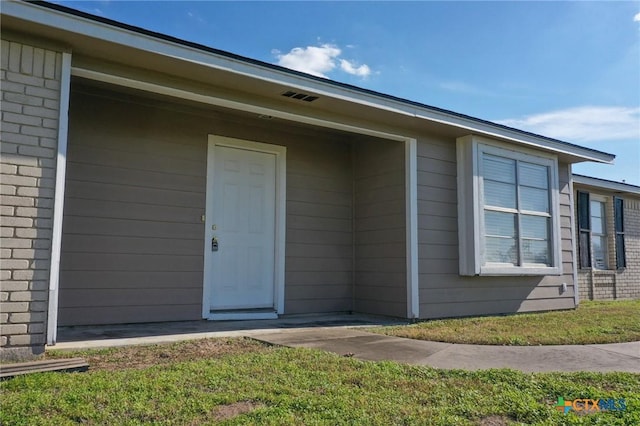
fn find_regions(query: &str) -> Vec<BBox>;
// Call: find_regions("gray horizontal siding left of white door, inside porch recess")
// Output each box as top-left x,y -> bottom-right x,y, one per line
59,92 -> 206,325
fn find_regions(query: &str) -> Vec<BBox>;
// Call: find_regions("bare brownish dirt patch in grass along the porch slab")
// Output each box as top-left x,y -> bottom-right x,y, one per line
45,338 -> 270,371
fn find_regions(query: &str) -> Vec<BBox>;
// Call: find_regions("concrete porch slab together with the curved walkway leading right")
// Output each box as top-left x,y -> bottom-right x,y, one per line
48,315 -> 640,373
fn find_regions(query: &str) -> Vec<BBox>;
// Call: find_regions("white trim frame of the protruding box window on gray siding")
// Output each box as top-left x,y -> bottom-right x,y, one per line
456,135 -> 562,276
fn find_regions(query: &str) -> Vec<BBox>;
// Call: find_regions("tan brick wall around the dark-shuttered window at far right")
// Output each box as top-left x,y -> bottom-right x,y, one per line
574,184 -> 640,300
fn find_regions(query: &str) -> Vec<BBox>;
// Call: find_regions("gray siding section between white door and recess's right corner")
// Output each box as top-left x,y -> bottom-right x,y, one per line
285,140 -> 353,314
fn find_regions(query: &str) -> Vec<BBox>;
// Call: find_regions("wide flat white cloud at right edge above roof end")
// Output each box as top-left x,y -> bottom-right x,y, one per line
496,106 -> 640,142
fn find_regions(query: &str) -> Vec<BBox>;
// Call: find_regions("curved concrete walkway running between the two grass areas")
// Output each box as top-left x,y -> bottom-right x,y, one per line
255,329 -> 640,373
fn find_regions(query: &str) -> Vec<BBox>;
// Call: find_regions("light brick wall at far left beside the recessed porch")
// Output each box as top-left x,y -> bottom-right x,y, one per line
0,40 -> 62,359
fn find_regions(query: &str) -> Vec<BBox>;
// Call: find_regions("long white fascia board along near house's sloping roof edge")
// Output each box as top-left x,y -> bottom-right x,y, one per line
2,1 -> 615,163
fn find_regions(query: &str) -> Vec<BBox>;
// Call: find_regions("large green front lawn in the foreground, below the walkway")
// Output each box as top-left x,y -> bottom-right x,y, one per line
0,339 -> 640,426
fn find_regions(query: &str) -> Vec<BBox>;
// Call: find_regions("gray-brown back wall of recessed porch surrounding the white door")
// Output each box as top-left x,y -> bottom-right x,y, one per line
59,86 -> 353,325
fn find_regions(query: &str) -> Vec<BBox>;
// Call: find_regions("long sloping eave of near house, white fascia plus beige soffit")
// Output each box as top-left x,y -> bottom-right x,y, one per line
2,1 -> 615,163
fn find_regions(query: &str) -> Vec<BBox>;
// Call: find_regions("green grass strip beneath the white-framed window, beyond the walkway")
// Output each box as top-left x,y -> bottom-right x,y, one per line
369,300 -> 640,345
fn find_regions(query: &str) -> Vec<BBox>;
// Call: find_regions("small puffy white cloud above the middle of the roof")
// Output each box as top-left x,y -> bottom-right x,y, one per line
273,44 -> 371,78
